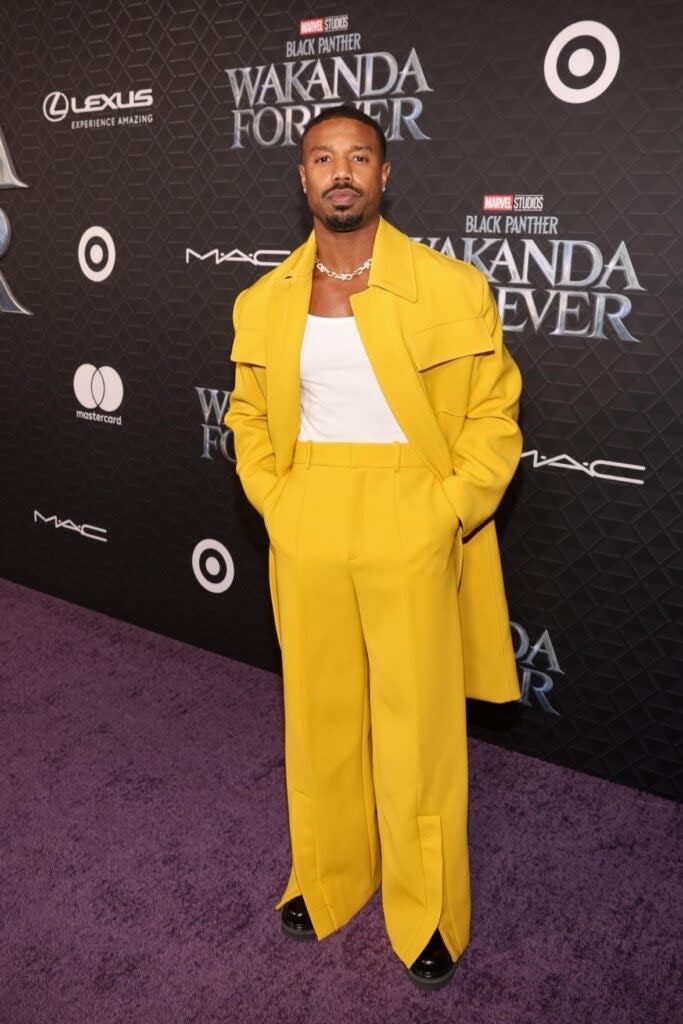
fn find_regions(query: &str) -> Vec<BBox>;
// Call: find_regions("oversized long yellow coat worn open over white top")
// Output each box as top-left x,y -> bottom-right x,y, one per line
224,217 -> 522,702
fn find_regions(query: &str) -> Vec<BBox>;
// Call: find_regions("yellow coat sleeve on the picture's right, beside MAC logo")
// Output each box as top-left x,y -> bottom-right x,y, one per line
443,274 -> 522,536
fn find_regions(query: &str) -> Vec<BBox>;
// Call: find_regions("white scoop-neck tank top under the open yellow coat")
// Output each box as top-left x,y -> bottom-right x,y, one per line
299,313 -> 408,441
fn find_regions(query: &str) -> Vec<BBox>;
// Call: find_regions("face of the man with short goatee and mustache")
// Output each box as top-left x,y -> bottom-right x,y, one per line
299,117 -> 391,231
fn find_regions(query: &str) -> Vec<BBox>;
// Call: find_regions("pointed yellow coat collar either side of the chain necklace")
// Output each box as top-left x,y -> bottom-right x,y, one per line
278,211 -> 417,302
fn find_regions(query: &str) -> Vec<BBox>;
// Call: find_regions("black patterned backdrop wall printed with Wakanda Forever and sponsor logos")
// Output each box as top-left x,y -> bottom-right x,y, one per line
0,0 -> 683,797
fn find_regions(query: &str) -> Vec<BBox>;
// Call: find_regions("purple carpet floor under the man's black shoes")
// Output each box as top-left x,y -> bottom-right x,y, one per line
0,581 -> 683,1024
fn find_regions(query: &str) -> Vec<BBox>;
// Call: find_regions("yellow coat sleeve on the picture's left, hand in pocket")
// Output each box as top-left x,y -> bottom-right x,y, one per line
223,292 -> 278,515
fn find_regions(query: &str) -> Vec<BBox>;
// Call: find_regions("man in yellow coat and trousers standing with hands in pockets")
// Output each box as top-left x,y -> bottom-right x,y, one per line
224,105 -> 521,988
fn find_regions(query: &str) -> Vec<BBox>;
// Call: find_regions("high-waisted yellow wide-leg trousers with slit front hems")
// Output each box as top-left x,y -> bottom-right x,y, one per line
263,440 -> 470,967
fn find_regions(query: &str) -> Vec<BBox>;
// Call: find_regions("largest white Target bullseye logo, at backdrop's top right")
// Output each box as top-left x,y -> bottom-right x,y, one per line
543,22 -> 620,103
